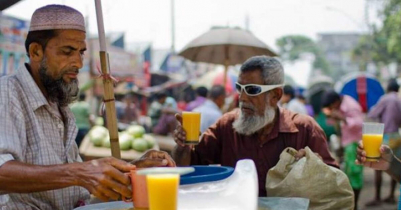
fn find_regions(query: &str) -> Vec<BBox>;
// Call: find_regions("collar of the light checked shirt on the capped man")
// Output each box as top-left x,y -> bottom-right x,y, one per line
16,64 -> 48,110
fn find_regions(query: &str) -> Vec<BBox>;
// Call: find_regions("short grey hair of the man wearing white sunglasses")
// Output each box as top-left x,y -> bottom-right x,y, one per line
240,55 -> 284,85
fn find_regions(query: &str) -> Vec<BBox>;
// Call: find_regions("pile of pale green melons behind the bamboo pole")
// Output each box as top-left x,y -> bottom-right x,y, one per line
88,125 -> 156,152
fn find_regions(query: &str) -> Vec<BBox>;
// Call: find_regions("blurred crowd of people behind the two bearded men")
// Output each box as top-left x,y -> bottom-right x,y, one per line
71,75 -> 401,206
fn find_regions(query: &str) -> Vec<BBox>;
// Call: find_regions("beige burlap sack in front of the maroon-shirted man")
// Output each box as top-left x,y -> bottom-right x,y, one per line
266,147 -> 354,210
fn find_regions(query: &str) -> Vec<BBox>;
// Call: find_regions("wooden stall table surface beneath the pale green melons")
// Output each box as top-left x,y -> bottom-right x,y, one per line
79,136 -> 159,161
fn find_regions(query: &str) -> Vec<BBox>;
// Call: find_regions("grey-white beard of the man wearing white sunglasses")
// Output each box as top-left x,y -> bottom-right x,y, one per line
233,99 -> 276,136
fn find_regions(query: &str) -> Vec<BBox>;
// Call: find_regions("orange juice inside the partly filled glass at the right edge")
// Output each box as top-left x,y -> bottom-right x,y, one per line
362,134 -> 383,161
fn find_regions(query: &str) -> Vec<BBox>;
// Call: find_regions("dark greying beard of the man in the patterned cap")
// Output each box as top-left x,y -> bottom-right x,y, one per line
39,58 -> 79,107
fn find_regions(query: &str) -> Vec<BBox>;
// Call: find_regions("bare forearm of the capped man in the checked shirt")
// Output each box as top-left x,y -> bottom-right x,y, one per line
0,161 -> 78,193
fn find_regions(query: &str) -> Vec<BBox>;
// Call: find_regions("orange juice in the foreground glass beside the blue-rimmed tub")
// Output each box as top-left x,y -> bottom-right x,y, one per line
146,174 -> 180,210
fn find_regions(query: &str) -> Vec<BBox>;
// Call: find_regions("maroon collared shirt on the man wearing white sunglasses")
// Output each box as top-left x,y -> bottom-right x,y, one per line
191,108 -> 338,196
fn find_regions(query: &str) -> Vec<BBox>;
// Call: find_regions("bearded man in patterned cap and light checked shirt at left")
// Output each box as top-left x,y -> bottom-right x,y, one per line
0,5 -> 175,210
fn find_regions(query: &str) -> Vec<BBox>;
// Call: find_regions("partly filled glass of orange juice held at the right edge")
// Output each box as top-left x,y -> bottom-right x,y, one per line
362,123 -> 384,161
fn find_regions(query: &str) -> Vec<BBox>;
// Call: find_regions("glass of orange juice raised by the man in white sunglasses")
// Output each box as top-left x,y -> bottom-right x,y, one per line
182,112 -> 201,144
